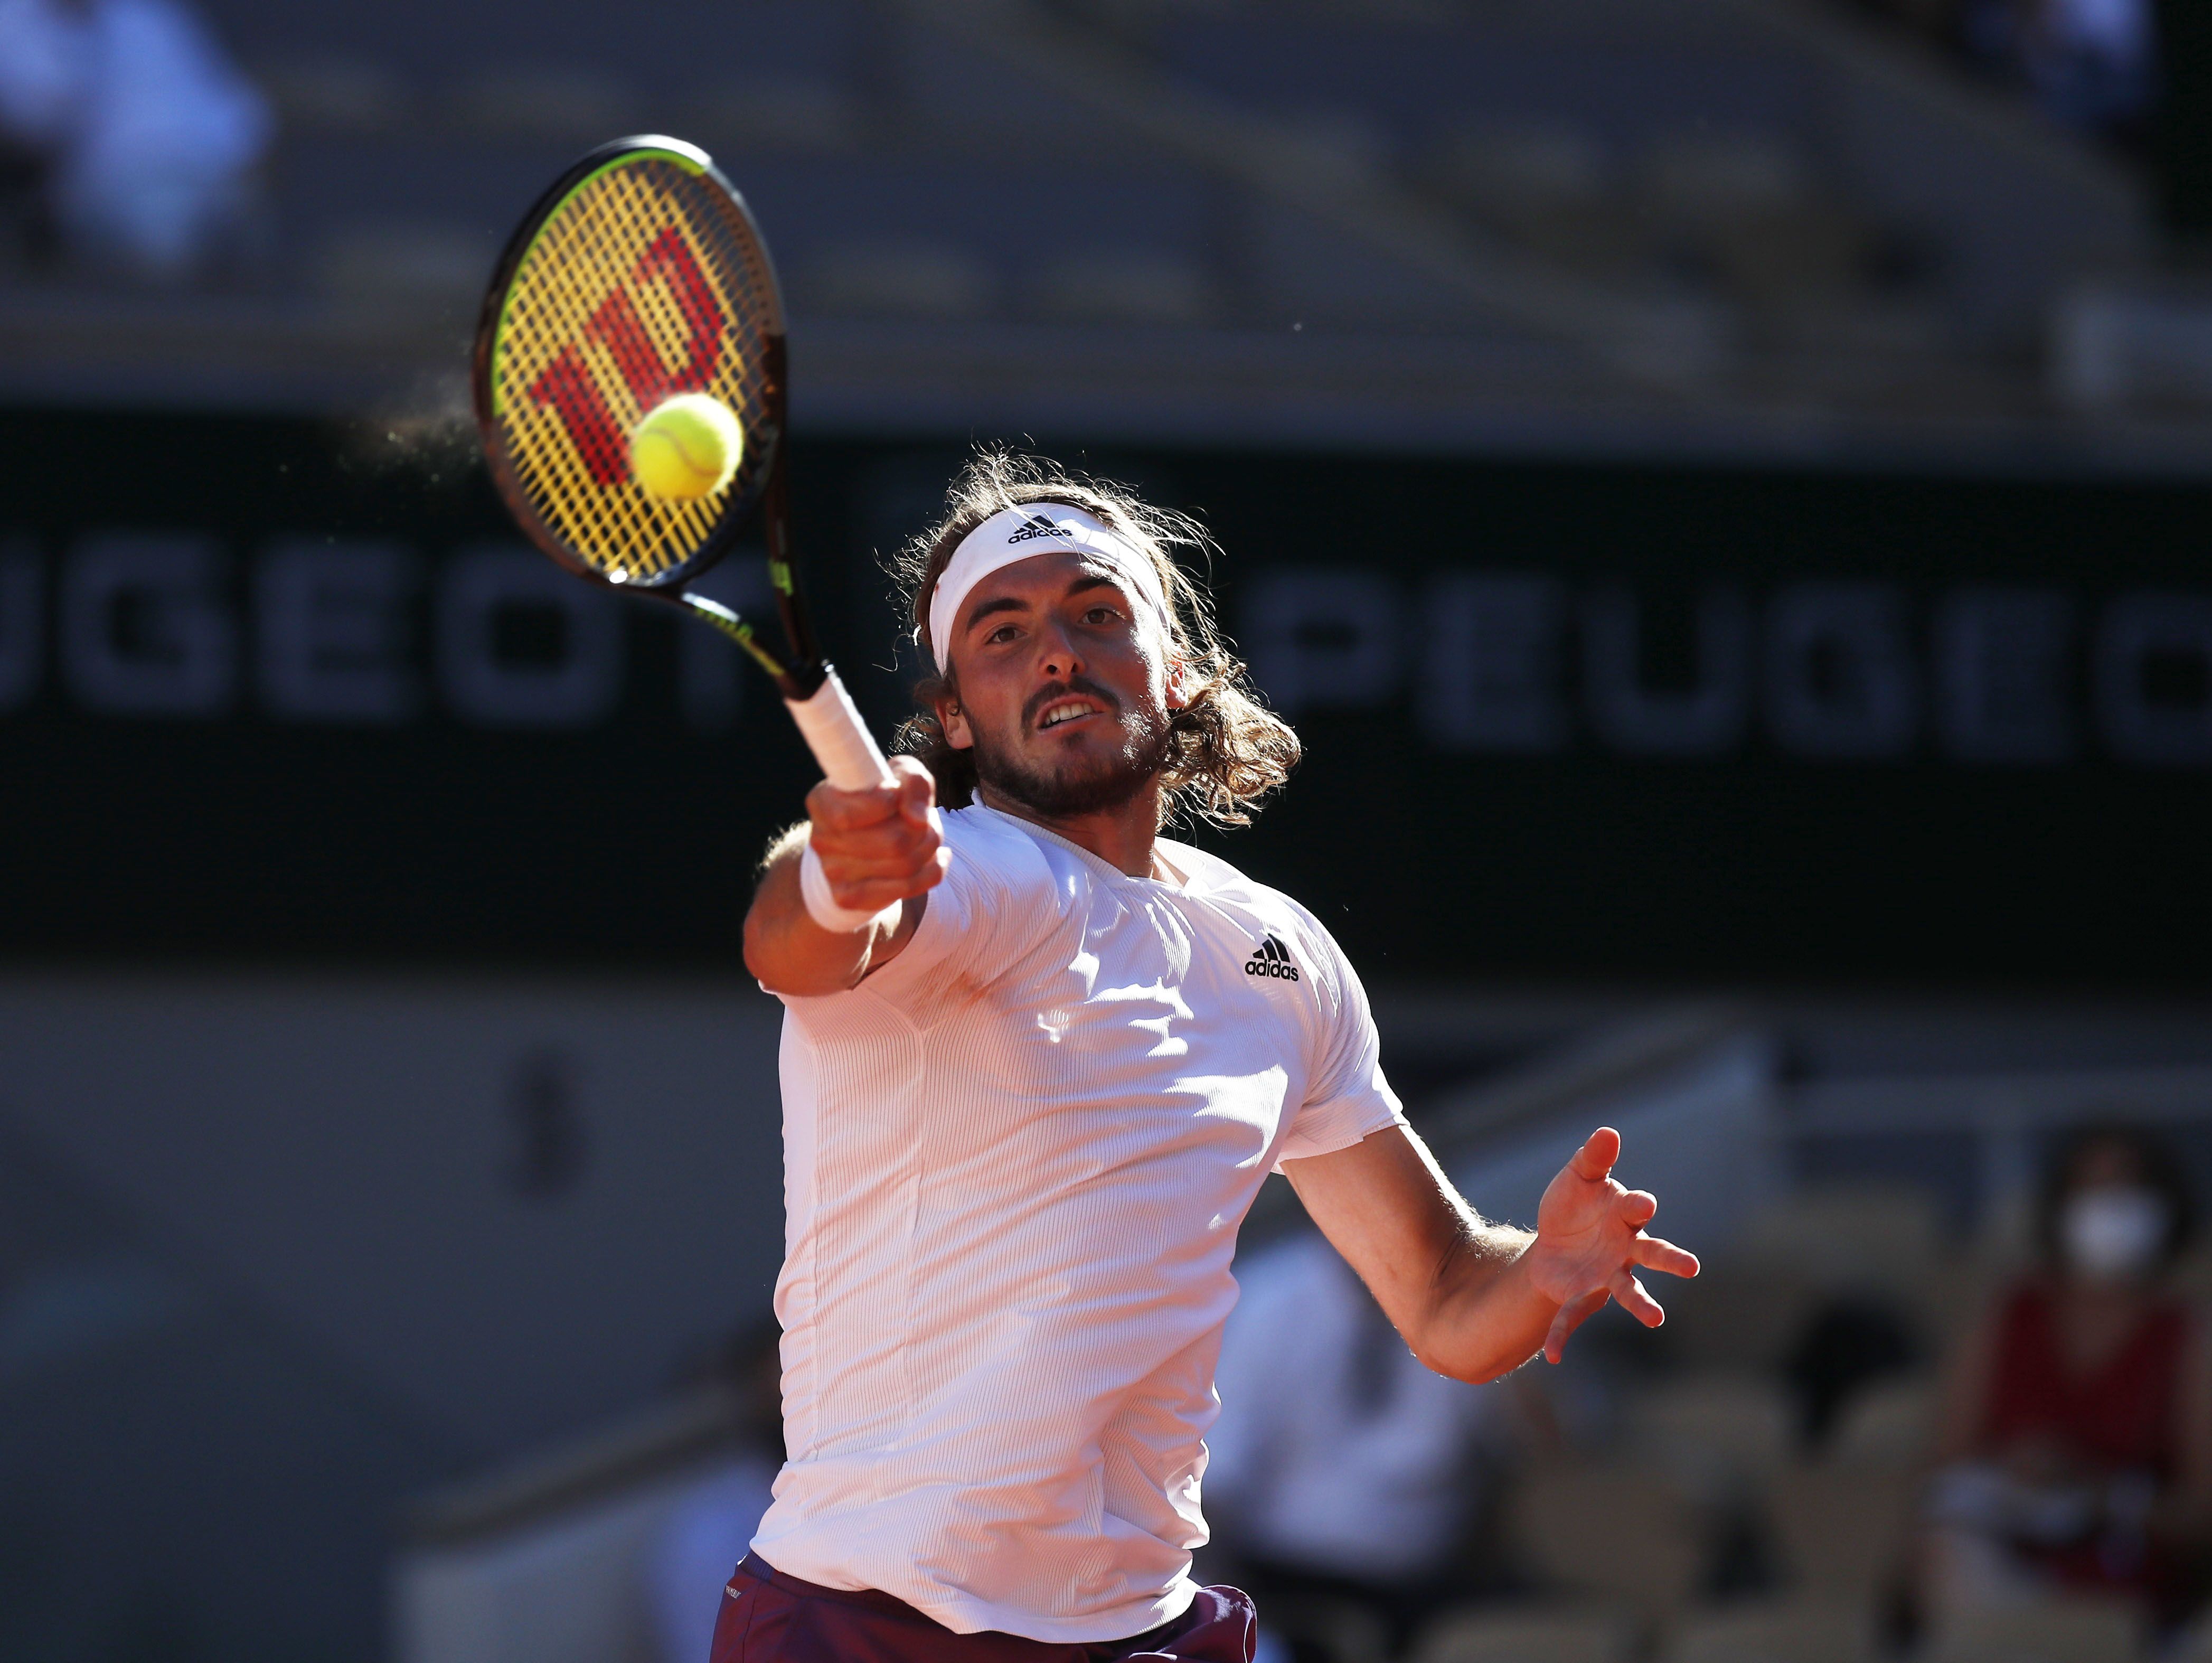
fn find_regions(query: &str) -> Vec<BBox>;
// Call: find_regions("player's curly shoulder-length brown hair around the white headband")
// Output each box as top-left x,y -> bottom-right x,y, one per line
889,449 -> 1298,827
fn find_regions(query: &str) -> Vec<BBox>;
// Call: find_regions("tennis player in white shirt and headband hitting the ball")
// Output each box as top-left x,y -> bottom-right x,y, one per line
714,456 -> 1697,1663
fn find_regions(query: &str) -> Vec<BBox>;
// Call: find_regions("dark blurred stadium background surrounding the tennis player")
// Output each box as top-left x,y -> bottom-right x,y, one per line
0,0 -> 2212,1663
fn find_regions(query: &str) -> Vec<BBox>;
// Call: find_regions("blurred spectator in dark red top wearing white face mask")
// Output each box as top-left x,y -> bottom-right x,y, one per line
1927,1130 -> 2212,1612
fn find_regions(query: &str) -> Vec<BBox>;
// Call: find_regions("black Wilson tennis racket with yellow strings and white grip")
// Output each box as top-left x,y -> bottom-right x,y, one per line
473,135 -> 891,792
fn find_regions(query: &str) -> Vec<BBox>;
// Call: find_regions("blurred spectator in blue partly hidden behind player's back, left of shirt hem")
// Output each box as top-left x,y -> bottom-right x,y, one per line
639,1322 -> 783,1663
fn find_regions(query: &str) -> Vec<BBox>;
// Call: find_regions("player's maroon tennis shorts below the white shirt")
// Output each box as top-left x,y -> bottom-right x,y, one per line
712,1553 -> 1259,1663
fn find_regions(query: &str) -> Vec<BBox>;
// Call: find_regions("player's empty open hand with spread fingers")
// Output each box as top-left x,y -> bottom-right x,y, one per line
1522,1125 -> 1697,1363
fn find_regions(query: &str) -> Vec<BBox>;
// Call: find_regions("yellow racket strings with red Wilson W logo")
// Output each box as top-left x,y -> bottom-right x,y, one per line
493,159 -> 776,581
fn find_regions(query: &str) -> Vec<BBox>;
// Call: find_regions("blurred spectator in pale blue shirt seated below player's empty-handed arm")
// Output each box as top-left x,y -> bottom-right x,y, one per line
1203,1234 -> 1530,1639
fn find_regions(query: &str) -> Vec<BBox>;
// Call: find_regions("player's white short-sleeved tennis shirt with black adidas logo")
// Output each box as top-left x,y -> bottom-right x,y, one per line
752,807 -> 1402,1643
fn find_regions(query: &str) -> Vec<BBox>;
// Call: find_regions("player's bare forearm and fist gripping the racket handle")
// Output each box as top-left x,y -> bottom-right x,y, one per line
746,756 -> 951,998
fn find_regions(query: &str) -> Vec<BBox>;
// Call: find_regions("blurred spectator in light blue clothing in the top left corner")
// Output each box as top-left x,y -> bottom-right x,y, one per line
0,0 -> 272,281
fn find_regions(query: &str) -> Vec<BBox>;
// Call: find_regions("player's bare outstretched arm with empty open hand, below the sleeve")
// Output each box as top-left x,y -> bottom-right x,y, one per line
1283,1125 -> 1697,1380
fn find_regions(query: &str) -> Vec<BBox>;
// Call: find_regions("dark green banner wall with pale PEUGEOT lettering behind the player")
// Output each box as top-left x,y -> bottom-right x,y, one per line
0,414 -> 2212,989
